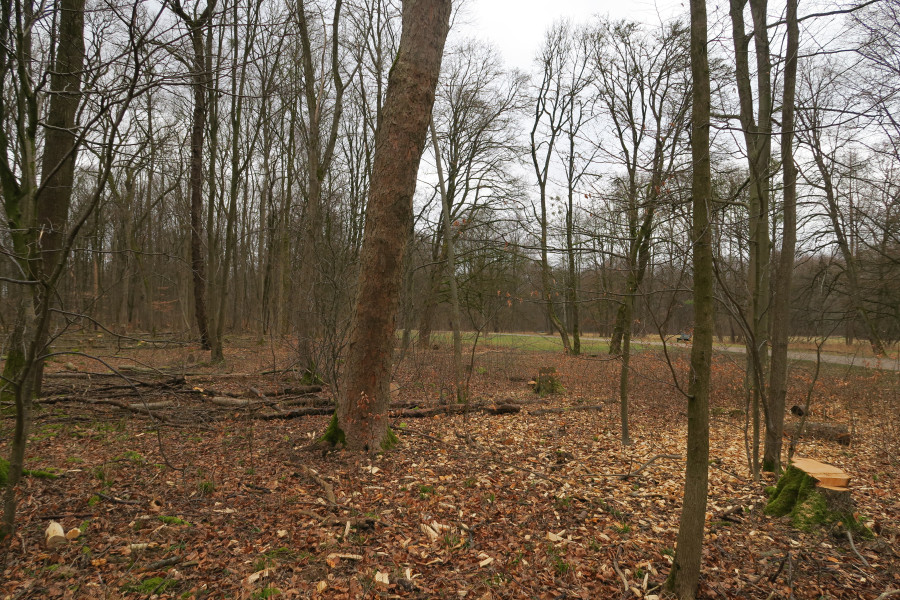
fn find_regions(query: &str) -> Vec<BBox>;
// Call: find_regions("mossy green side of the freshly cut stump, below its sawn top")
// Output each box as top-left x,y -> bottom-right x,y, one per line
765,466 -> 869,535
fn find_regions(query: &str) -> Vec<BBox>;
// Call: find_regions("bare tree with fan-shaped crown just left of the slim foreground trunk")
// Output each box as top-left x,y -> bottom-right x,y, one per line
594,22 -> 690,445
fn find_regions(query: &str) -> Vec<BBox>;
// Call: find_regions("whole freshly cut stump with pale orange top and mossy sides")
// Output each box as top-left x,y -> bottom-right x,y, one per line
766,458 -> 869,535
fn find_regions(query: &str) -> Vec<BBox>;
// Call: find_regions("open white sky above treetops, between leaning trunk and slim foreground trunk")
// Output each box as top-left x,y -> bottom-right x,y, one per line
460,0 -> 688,71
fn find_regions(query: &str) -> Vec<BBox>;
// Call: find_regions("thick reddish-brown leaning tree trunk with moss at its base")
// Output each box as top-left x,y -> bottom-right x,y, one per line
326,0 -> 451,451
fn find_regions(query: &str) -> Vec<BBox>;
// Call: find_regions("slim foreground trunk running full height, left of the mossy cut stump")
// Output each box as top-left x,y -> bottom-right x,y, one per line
665,0 -> 714,600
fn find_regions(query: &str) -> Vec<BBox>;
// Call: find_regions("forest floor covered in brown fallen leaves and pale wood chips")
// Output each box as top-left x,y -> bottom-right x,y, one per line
0,338 -> 900,600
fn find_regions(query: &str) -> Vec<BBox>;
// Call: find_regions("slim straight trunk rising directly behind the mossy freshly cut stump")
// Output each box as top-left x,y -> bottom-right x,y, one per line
762,0 -> 800,473
